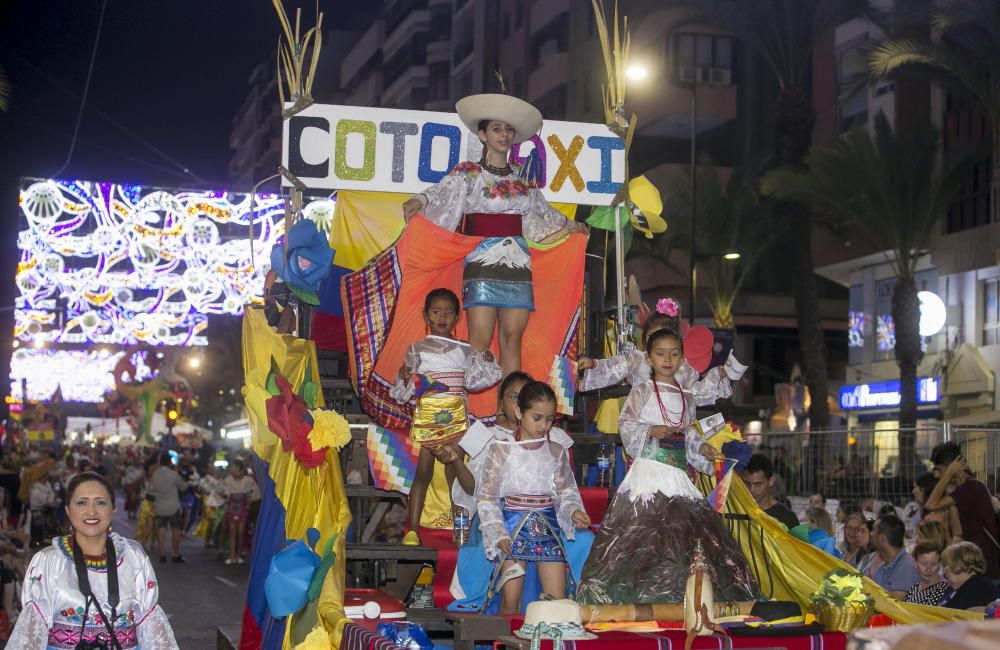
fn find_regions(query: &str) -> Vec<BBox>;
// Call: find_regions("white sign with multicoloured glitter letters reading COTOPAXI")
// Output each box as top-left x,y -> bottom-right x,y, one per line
281,104 -> 625,205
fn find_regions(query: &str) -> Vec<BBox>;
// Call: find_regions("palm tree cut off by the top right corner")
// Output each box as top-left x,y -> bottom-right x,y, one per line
869,0 -> 1000,221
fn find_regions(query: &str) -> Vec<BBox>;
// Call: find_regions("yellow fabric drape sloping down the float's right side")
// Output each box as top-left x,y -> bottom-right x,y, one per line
712,477 -> 983,624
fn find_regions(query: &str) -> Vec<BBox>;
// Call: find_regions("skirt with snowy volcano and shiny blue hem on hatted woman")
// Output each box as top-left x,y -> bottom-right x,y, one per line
462,237 -> 535,311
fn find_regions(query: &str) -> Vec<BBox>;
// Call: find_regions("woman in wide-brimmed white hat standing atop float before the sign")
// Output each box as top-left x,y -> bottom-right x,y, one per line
403,94 -> 586,376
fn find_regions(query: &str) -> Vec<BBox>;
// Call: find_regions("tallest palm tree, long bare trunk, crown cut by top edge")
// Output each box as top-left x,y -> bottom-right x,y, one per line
681,0 -> 872,428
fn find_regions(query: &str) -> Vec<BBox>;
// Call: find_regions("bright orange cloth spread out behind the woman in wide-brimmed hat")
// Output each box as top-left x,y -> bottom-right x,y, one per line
375,216 -> 587,417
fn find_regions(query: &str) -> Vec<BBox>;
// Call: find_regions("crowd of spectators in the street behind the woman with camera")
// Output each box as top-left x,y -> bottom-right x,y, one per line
0,438 -> 260,640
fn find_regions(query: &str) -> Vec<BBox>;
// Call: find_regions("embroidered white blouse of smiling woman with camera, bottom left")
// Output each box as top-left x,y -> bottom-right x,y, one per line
6,533 -> 178,650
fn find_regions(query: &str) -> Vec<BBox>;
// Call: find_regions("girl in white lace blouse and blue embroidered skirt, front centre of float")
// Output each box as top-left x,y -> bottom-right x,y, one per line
477,381 -> 590,615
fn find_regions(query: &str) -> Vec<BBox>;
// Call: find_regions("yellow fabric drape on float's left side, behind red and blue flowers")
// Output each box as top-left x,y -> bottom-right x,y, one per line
243,309 -> 351,650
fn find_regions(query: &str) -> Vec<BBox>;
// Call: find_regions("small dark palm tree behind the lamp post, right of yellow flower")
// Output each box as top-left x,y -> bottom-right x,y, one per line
634,164 -> 774,329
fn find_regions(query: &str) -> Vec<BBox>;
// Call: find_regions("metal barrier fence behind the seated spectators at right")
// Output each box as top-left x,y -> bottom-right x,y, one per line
747,422 -> 1000,505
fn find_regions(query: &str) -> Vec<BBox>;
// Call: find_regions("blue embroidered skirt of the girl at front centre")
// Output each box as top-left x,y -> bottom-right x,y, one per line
500,495 -> 566,562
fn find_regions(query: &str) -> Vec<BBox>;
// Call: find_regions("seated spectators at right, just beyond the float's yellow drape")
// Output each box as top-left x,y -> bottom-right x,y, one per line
743,442 -> 1000,609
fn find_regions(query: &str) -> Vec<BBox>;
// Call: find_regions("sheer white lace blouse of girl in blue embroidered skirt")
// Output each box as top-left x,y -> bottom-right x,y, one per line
477,432 -> 584,560
